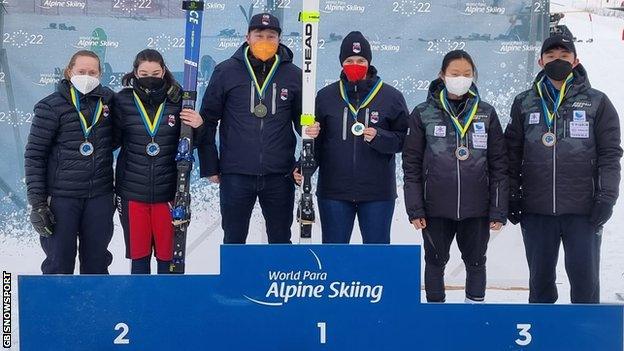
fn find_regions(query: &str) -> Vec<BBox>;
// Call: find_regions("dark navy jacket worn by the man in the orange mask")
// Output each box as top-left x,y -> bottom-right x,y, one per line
199,44 -> 301,177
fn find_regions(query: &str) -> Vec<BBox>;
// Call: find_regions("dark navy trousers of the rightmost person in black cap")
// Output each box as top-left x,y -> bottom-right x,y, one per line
521,214 -> 602,303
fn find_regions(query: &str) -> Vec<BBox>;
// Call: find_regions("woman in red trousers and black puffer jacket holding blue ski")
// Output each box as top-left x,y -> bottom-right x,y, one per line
113,49 -> 203,274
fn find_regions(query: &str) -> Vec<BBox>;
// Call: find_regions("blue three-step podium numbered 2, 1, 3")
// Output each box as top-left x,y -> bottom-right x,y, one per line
19,245 -> 624,351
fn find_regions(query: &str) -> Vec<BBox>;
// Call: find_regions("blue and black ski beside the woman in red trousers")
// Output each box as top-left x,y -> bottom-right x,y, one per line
169,0 -> 204,273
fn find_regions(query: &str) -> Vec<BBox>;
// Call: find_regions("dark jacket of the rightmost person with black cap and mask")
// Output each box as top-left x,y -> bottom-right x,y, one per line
505,65 -> 622,215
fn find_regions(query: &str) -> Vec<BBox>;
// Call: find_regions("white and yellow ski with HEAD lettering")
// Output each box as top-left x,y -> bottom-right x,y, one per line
297,0 -> 320,241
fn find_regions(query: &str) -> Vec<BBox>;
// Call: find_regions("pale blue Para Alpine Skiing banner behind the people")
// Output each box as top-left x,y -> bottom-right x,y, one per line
0,0 -> 549,239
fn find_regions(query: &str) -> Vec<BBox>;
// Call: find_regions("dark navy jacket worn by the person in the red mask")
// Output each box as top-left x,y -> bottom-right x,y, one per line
314,66 -> 409,201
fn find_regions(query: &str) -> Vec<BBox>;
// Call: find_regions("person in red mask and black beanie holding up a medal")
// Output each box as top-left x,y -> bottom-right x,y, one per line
295,32 -> 409,244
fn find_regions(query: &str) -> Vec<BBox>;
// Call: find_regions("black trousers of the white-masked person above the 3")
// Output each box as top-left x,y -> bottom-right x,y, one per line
423,217 -> 490,302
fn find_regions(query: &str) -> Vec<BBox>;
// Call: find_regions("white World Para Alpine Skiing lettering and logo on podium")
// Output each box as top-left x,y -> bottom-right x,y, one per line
243,249 -> 384,307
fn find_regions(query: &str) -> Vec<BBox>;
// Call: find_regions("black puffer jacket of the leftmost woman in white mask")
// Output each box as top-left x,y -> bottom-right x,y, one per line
24,80 -> 113,206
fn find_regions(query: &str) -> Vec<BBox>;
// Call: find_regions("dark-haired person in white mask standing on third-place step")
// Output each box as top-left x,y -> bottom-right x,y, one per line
403,50 -> 508,302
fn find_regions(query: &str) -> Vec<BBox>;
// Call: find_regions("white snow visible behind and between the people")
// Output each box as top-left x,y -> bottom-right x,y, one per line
0,0 -> 624,350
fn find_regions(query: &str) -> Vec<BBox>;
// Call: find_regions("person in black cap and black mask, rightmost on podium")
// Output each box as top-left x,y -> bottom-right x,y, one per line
505,35 -> 622,303
